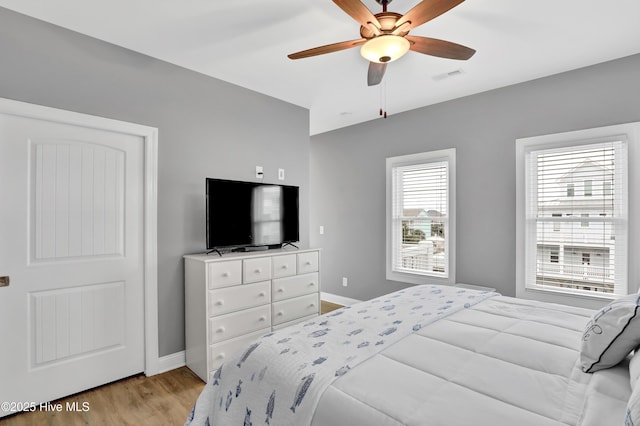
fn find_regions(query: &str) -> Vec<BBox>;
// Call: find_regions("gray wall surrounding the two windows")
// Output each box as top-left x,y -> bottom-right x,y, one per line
310,55 -> 640,299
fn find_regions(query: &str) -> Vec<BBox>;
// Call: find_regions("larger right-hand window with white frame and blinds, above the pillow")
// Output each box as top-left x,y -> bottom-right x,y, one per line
516,123 -> 640,306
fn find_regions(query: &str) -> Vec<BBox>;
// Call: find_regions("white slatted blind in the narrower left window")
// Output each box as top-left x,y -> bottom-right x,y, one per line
391,161 -> 449,277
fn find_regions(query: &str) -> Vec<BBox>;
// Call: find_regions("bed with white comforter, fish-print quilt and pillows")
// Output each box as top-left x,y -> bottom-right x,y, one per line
186,285 -> 640,426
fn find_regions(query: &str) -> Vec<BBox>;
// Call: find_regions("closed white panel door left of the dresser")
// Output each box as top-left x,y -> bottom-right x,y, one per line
0,105 -> 145,417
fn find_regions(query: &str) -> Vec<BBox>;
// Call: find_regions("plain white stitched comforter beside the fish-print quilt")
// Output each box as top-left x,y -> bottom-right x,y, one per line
312,296 -> 631,426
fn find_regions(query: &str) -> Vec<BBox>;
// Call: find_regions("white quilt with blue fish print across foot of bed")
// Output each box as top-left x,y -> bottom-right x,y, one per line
185,285 -> 497,426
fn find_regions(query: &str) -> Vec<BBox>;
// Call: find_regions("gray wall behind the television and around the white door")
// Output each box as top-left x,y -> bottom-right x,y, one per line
0,8 -> 310,356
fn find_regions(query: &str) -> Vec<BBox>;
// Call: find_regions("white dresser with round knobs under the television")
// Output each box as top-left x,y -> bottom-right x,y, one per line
184,249 -> 320,381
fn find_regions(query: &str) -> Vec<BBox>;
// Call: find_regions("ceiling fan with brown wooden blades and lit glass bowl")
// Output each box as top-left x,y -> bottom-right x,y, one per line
288,0 -> 476,86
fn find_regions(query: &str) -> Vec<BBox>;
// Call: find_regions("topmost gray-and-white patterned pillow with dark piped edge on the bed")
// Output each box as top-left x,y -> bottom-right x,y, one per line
580,294 -> 640,373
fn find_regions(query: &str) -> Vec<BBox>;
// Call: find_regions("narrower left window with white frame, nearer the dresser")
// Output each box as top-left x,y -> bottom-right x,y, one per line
387,149 -> 455,284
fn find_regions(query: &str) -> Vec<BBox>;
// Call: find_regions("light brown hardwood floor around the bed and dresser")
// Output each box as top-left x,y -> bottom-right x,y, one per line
0,300 -> 342,426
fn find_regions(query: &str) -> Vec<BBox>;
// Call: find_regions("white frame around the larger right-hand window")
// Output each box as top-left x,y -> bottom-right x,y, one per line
516,122 -> 640,309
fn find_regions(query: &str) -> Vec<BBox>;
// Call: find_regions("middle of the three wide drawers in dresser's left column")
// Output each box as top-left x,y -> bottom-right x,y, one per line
209,305 -> 271,343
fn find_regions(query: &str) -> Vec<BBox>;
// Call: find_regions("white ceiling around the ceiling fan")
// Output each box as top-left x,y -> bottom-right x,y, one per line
0,0 -> 640,135
